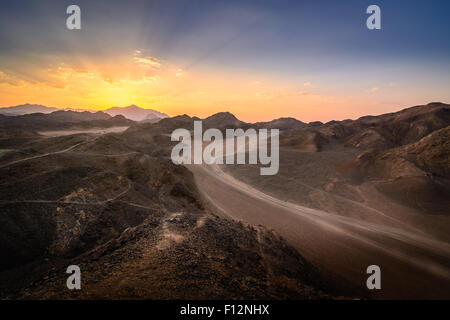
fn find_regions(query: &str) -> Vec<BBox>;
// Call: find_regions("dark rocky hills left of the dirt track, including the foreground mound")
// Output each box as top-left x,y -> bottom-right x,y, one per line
0,129 -> 328,299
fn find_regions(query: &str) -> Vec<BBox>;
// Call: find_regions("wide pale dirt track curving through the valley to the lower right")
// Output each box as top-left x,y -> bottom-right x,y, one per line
189,165 -> 450,298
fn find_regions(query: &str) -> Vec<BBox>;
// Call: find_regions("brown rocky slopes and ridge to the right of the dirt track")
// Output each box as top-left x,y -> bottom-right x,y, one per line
224,103 -> 450,220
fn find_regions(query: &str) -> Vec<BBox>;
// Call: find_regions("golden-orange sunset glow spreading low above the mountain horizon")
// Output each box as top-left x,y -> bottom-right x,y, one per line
0,50 -> 422,122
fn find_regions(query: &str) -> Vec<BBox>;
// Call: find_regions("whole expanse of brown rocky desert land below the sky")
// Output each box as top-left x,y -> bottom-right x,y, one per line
0,103 -> 450,299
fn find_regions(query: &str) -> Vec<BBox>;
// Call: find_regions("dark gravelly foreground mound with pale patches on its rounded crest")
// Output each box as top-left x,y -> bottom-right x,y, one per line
14,211 -> 327,299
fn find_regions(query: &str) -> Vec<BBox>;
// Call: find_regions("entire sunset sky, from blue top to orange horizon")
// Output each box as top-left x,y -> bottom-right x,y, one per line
0,0 -> 450,122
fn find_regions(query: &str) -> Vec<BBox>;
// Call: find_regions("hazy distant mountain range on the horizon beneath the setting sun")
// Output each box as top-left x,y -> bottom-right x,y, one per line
0,103 -> 168,122
